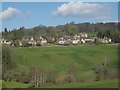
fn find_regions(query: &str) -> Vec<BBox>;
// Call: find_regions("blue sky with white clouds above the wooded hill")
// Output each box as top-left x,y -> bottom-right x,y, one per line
0,2 -> 118,30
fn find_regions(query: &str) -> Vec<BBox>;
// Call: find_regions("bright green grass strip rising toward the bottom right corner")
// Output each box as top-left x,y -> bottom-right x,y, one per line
46,79 -> 118,88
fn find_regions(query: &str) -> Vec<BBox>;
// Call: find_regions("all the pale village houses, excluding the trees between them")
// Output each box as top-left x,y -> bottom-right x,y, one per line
0,33 -> 111,46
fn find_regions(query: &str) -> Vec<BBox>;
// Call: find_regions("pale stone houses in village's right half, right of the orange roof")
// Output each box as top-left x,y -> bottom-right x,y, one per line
58,33 -> 111,44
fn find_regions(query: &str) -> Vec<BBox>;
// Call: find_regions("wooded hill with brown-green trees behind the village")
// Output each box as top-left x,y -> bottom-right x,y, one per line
2,22 -> 119,40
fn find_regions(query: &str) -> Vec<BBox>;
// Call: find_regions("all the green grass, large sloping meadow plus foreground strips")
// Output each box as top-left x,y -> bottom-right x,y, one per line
3,45 -> 118,87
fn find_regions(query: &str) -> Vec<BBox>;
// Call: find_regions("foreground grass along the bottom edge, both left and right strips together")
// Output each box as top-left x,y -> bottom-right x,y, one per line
3,79 -> 118,88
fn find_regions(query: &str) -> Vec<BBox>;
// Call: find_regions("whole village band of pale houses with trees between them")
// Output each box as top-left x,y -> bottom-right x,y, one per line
0,33 -> 112,47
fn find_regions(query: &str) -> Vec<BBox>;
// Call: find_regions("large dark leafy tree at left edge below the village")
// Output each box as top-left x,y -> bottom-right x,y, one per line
2,45 -> 16,81
